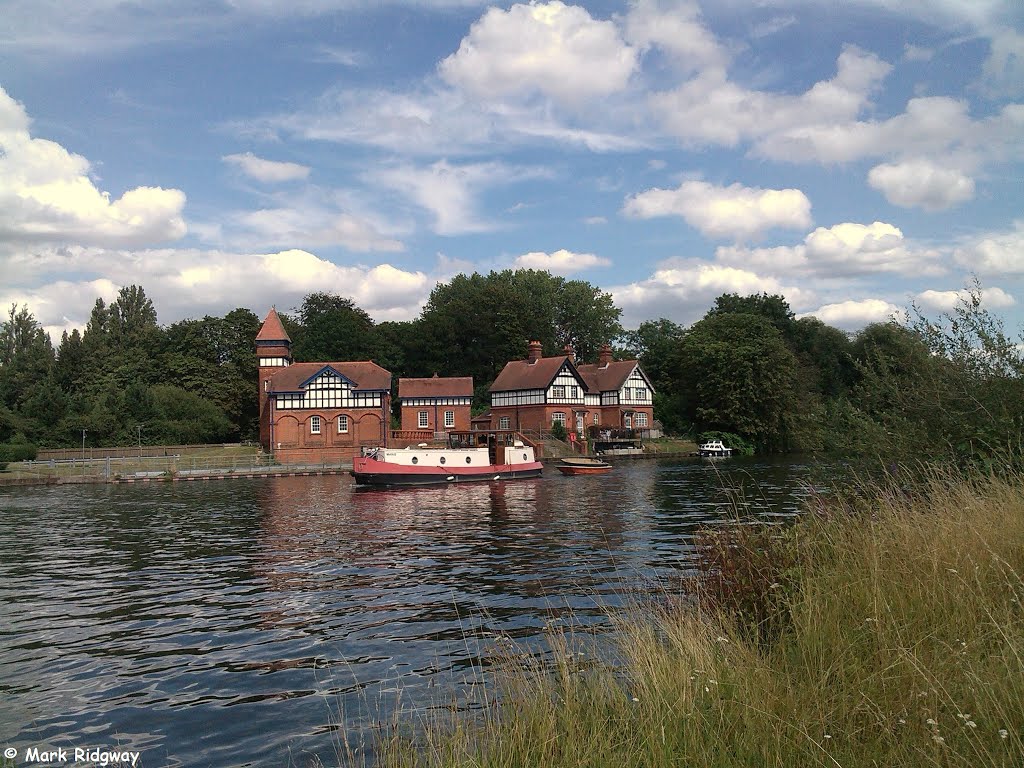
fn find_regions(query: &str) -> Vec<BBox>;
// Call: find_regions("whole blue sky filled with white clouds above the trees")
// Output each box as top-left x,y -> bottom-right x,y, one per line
0,0 -> 1024,342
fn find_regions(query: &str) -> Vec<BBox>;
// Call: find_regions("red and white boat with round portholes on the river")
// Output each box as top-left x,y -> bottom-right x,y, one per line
352,431 -> 544,485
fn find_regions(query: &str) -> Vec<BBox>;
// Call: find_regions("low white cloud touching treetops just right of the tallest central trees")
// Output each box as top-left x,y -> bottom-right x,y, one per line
608,260 -> 813,328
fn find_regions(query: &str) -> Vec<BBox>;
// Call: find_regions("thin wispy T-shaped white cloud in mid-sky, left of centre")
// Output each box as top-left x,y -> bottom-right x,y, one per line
367,160 -> 548,234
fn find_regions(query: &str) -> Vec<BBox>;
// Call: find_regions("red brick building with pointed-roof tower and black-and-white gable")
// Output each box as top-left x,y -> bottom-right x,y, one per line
256,309 -> 391,464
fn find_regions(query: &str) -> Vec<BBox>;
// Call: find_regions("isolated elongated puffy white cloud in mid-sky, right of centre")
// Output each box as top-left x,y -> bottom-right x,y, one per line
623,181 -> 811,240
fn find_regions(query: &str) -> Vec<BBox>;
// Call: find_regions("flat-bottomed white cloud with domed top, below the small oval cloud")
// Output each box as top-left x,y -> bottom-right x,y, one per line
715,221 -> 944,278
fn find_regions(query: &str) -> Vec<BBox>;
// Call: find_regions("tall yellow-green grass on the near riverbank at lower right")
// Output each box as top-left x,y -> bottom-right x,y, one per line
379,473 -> 1024,768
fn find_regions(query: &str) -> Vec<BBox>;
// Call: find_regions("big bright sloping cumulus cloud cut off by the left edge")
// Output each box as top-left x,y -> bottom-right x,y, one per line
0,88 -> 185,246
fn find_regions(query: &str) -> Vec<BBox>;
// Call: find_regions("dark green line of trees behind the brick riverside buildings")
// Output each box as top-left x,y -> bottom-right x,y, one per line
0,269 -> 1024,461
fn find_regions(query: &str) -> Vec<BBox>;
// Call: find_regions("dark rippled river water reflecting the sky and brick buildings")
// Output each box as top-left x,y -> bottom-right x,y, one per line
0,459 -> 814,768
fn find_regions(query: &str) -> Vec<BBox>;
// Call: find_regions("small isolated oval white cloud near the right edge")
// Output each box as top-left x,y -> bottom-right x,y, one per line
867,160 -> 974,211
